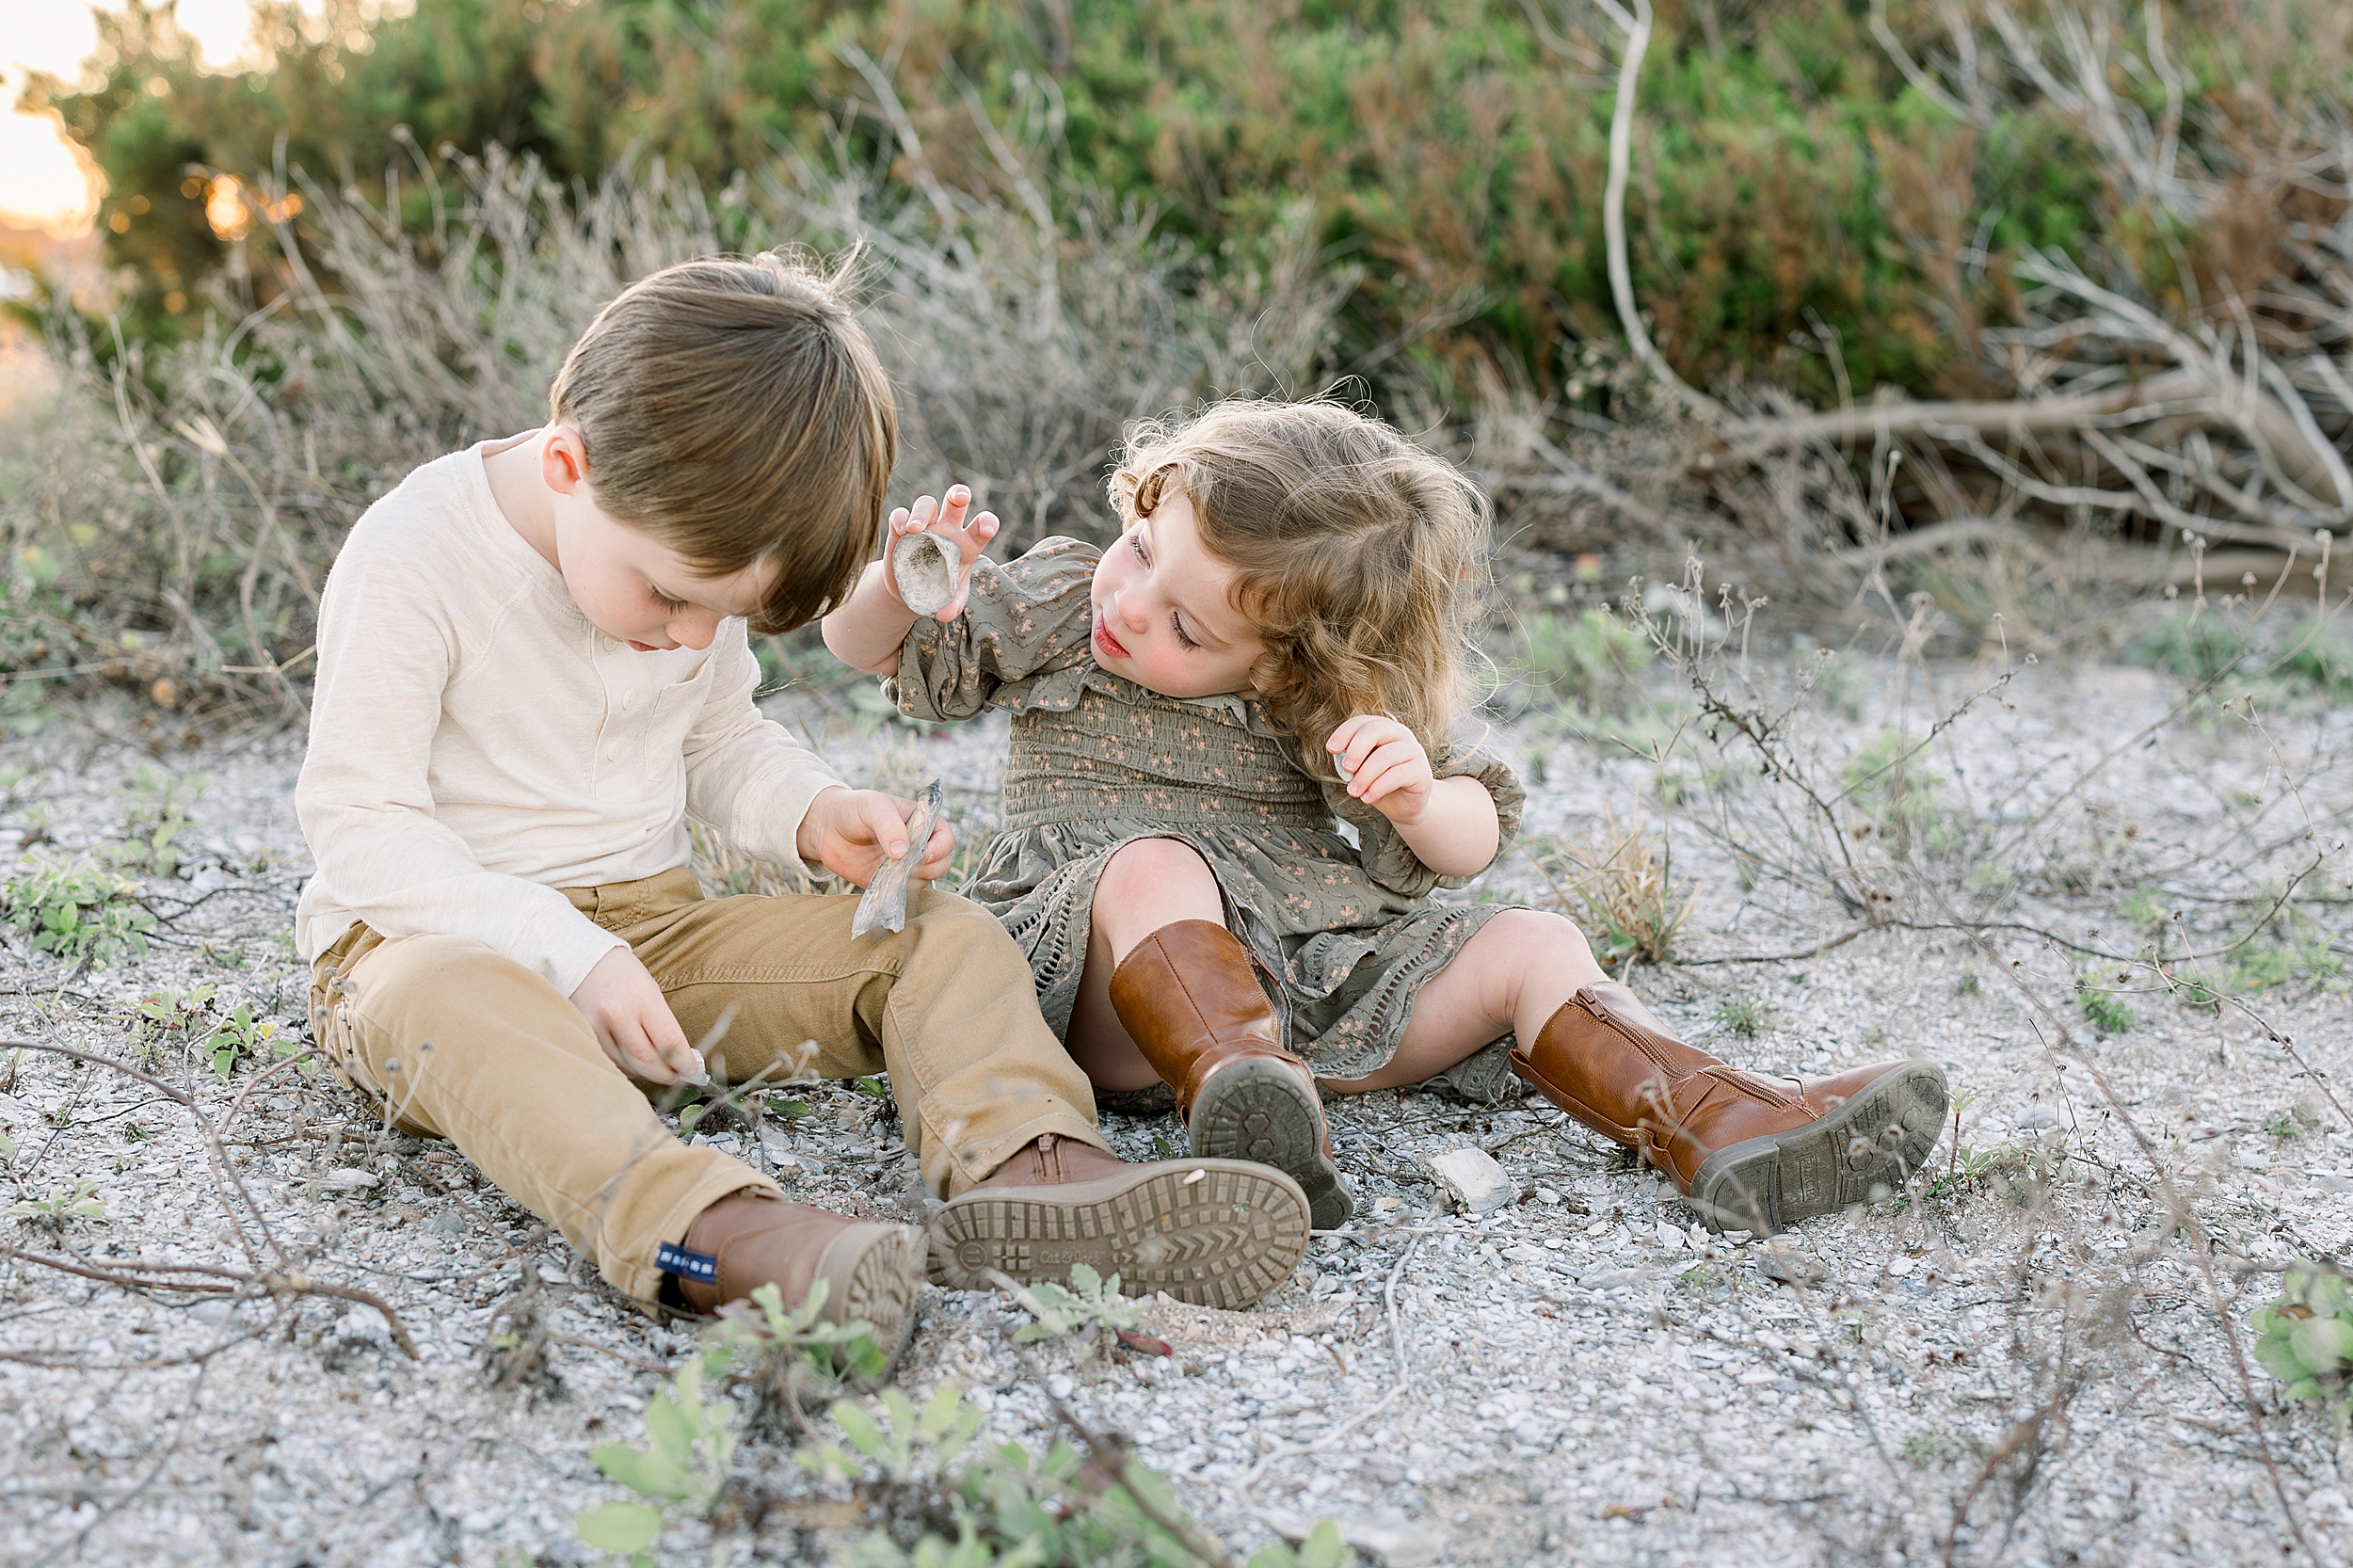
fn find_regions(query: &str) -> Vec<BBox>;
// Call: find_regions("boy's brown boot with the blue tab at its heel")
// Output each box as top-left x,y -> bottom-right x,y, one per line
654,1187 -> 922,1361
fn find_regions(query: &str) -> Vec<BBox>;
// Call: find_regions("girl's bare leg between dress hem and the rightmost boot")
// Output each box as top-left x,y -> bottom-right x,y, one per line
1327,909 -> 1609,1095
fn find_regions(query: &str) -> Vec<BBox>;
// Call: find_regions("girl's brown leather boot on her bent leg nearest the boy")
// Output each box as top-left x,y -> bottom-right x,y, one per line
1111,920 -> 1355,1231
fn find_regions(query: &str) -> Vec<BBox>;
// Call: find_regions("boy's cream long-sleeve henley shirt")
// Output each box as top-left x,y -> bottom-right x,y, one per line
295,436 -> 840,996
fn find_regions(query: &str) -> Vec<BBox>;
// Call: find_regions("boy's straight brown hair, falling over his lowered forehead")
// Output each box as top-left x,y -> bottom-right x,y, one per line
549,252 -> 899,633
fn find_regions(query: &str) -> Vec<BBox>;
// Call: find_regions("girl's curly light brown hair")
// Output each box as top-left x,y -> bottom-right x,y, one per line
1111,398 -> 1490,779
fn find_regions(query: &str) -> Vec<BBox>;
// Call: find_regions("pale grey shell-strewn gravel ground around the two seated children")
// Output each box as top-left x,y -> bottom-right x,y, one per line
0,645 -> 2353,1565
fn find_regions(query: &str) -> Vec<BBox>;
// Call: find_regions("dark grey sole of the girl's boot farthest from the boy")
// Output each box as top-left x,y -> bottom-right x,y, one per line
1689,1062 -> 1951,1236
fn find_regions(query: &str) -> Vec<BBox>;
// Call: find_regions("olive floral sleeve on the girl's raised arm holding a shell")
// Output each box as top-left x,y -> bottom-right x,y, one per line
883,536 -> 1101,723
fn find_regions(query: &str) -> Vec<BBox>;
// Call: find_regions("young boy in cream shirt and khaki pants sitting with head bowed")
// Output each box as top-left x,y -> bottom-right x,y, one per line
296,257 -> 1308,1349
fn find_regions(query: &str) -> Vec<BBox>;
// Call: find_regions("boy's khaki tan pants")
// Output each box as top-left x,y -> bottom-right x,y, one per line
311,869 -> 1106,1302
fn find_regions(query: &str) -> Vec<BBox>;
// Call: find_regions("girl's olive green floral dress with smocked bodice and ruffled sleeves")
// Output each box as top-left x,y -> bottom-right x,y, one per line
888,539 -> 1523,1080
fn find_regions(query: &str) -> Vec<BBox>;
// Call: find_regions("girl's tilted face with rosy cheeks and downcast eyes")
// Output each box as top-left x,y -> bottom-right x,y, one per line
1090,488 -> 1266,696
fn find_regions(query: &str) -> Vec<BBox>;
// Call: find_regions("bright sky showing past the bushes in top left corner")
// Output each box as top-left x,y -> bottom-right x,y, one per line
0,0 -> 315,235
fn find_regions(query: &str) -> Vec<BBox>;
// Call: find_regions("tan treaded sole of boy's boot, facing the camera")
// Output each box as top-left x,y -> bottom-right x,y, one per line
932,1160 -> 1308,1311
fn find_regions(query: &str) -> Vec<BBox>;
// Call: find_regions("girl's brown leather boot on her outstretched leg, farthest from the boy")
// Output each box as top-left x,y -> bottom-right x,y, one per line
1511,982 -> 1948,1236
